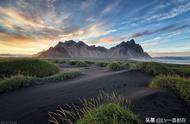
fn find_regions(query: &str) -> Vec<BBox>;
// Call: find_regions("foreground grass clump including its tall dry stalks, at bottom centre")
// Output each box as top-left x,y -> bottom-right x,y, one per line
49,92 -> 140,124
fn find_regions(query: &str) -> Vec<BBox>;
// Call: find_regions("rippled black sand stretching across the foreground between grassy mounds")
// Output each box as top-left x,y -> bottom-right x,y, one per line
0,66 -> 190,124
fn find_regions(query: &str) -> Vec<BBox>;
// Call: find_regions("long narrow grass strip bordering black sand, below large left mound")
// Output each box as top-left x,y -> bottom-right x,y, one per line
0,71 -> 81,93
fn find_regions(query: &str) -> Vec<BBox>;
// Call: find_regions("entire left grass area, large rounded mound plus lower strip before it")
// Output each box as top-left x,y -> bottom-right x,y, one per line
0,58 -> 81,93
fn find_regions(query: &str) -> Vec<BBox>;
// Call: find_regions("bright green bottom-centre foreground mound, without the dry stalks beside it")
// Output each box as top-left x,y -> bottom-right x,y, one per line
77,103 -> 138,124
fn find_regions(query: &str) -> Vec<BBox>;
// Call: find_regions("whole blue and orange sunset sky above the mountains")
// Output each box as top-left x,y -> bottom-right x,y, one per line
0,0 -> 190,56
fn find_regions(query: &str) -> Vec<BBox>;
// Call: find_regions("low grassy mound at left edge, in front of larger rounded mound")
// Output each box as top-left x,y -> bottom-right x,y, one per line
0,75 -> 37,93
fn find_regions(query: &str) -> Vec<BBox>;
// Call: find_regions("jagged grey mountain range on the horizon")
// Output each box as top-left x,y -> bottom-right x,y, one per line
36,39 -> 150,59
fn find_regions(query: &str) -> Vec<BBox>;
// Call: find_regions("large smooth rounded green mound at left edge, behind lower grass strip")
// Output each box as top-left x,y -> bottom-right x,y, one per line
0,58 -> 59,77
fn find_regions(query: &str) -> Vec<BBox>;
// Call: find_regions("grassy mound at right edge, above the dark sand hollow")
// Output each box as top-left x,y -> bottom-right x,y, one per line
150,76 -> 190,104
